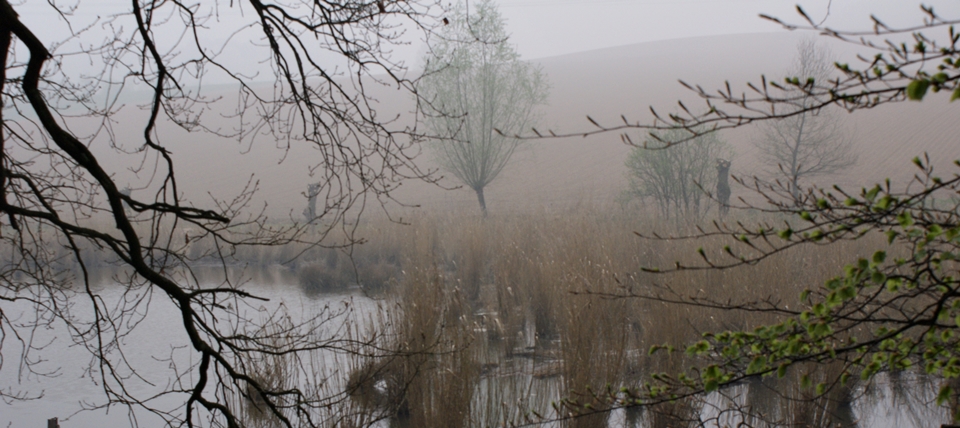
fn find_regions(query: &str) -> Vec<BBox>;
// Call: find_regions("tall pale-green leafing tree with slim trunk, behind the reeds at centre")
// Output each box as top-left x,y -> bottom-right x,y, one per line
418,0 -> 548,215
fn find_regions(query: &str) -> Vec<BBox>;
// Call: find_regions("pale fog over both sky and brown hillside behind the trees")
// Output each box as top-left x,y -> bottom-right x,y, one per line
18,0 -> 960,219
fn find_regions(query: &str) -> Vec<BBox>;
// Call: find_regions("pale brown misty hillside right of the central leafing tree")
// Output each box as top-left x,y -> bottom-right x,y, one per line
404,32 -> 960,211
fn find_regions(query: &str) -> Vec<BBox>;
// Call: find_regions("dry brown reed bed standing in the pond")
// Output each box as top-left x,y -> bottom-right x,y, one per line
182,209 -> 946,427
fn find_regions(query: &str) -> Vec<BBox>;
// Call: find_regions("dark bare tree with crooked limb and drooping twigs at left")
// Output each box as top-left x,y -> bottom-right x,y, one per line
0,0 -> 442,427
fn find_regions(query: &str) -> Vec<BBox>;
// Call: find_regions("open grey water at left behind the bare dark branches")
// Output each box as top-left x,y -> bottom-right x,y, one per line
0,271 -> 377,428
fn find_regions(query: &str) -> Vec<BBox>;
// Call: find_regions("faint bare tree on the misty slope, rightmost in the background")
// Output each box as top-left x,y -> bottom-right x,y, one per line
754,39 -> 857,197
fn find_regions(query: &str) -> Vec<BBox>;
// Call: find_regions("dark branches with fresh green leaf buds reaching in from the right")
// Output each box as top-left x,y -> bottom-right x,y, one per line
538,5 -> 960,425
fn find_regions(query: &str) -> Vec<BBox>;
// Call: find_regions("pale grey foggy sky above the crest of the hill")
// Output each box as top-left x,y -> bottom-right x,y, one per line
14,0 -> 960,65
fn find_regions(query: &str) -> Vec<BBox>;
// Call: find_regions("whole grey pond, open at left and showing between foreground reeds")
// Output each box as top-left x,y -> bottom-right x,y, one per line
0,270 -> 948,428
